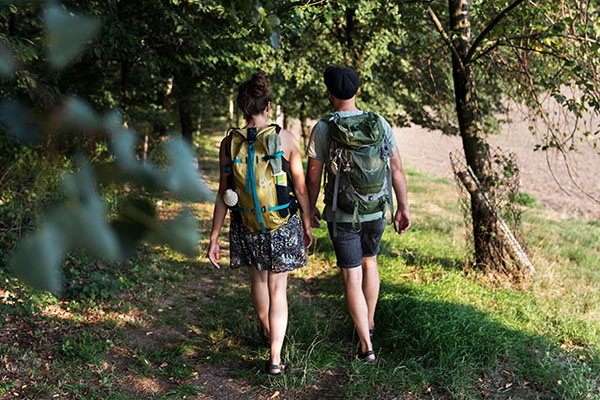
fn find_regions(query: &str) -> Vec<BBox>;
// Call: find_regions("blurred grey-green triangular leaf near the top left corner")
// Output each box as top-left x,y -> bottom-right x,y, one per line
44,5 -> 99,69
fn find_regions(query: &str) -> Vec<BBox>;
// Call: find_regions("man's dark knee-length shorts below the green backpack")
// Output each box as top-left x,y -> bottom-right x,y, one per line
327,218 -> 385,268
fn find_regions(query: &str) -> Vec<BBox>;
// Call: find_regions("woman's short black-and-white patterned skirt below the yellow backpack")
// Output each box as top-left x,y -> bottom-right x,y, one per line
229,214 -> 308,273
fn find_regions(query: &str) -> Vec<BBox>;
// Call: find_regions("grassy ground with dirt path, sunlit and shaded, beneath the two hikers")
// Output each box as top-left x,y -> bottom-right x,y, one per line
0,133 -> 600,399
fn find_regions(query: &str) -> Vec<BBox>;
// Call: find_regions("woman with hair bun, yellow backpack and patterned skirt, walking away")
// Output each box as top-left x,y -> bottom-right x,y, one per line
208,74 -> 312,375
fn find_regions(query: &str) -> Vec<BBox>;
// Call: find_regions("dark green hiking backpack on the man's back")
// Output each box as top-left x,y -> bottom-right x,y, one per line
325,113 -> 394,235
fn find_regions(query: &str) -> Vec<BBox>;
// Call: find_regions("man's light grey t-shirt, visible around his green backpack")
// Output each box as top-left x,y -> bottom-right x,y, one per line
306,111 -> 396,222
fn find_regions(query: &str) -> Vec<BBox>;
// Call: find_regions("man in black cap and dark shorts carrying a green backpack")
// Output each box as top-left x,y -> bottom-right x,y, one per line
306,67 -> 410,362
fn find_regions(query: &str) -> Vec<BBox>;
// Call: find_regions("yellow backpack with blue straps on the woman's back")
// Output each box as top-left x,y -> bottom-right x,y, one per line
225,125 -> 290,233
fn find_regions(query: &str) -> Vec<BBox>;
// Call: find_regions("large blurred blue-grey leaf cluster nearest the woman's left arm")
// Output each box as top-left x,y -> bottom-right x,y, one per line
12,115 -> 211,293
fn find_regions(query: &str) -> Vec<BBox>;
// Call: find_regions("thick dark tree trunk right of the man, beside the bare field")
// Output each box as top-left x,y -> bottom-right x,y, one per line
449,0 -> 505,270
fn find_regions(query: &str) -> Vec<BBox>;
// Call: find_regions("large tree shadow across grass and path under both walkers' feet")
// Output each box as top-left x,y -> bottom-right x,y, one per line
3,247 -> 600,399
